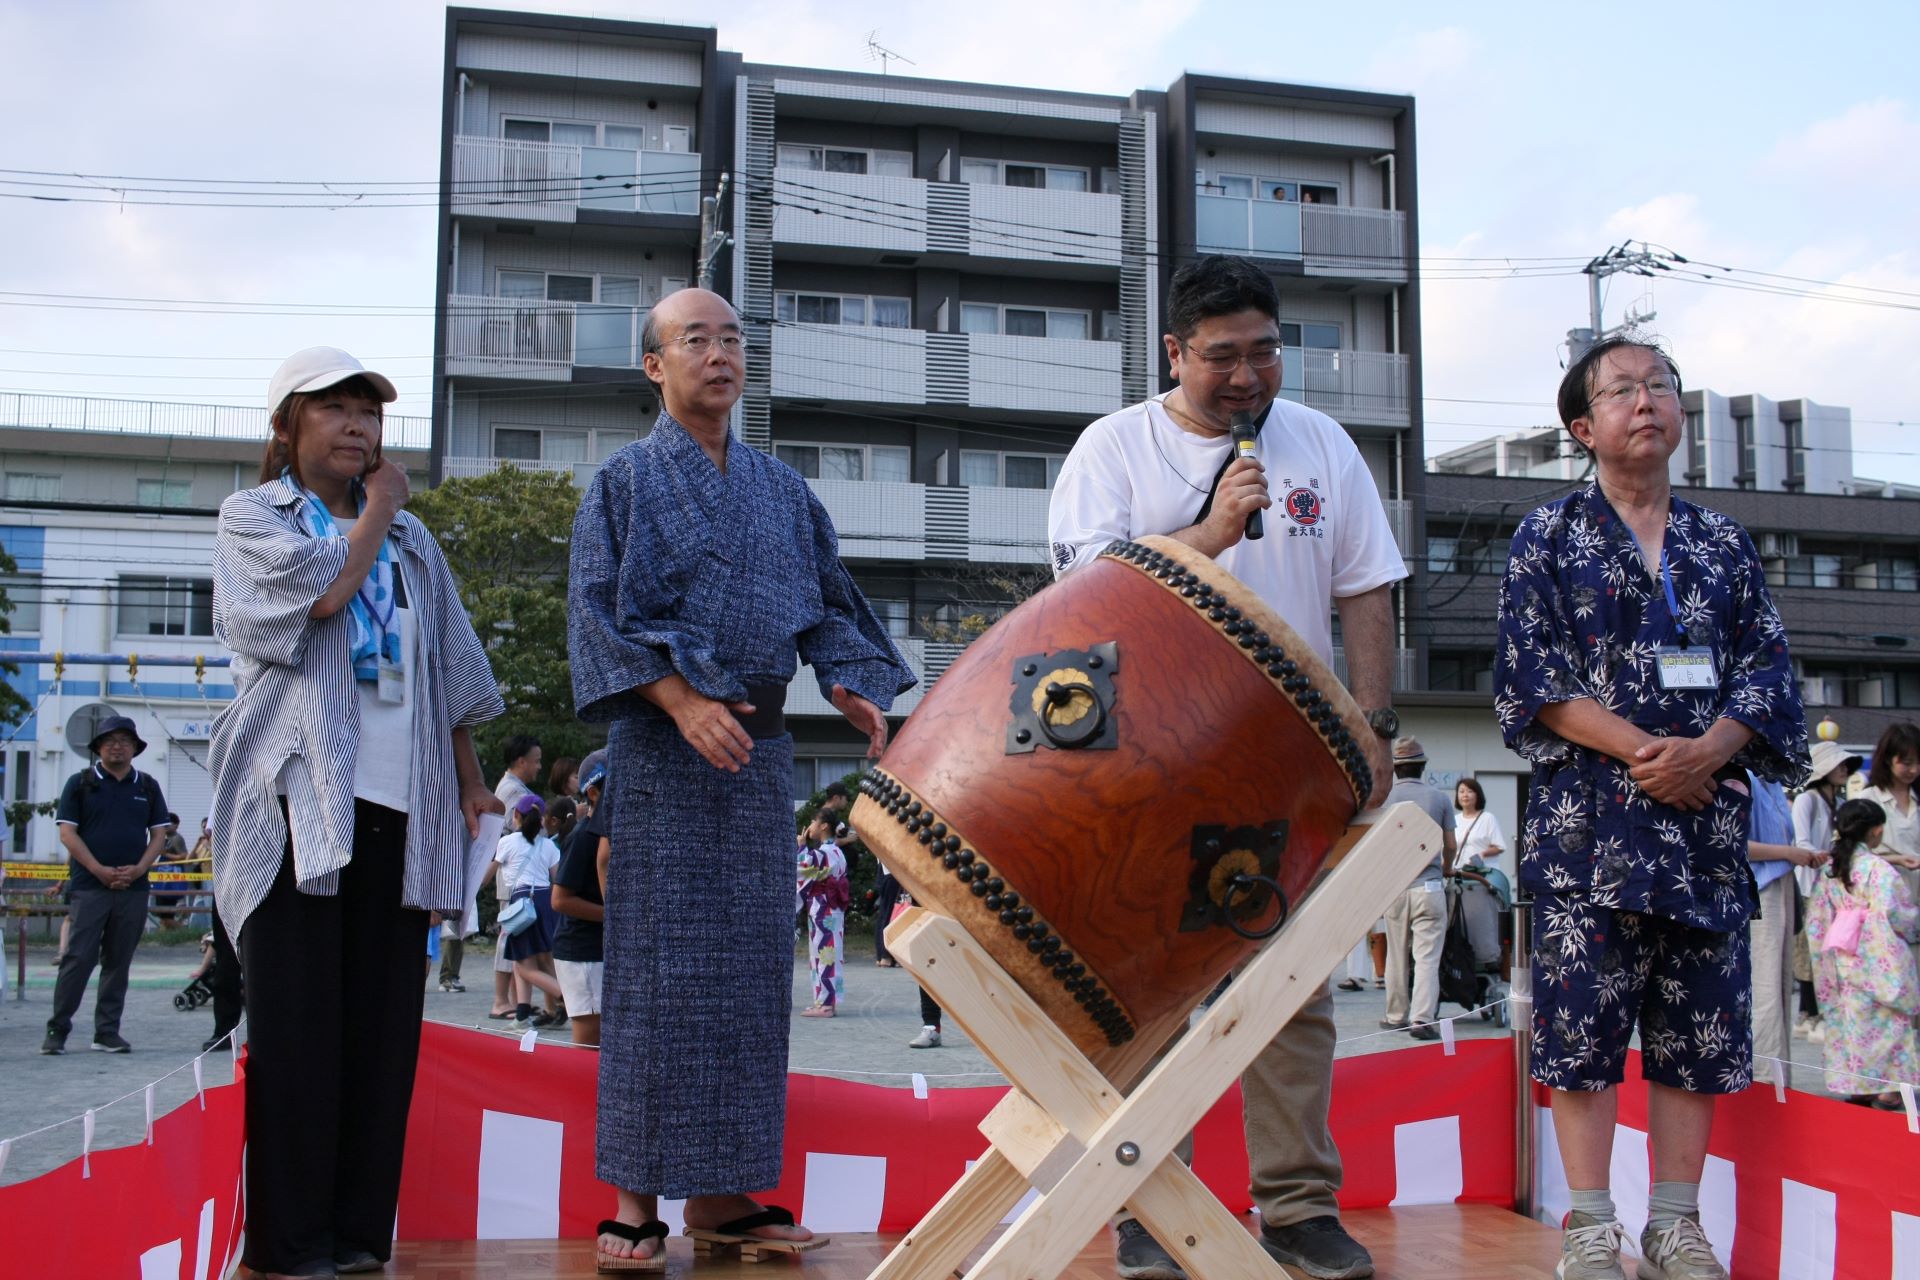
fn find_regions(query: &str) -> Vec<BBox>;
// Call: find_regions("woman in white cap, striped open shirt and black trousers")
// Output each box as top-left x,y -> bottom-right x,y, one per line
211,347 -> 503,1276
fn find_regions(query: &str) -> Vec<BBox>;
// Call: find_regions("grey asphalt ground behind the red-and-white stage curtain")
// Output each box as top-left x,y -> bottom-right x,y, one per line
0,933 -> 1820,1186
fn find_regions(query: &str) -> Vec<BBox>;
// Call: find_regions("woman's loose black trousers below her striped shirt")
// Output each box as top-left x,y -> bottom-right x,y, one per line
240,800 -> 426,1272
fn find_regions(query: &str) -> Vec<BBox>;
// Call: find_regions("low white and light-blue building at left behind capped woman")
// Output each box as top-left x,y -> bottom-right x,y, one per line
0,393 -> 430,858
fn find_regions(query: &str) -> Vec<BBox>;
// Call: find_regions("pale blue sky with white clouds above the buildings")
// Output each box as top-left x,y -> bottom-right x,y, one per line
0,0 -> 1920,482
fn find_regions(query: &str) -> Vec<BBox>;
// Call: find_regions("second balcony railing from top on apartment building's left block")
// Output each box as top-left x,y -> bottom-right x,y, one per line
447,294 -> 647,380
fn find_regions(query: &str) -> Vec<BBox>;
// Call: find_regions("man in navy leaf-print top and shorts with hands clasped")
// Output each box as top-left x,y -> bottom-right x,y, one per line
1494,338 -> 1807,1280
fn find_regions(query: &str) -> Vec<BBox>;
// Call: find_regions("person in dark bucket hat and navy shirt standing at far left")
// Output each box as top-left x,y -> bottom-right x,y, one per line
40,716 -> 167,1054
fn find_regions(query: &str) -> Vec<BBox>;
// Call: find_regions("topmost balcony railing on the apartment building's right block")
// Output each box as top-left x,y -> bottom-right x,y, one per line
1194,192 -> 1407,280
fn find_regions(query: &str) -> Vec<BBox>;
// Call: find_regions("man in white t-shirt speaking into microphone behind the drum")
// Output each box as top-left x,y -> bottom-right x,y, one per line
1048,257 -> 1407,1280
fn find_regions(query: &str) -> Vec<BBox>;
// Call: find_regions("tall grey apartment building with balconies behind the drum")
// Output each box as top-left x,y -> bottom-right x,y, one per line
434,10 -> 1423,793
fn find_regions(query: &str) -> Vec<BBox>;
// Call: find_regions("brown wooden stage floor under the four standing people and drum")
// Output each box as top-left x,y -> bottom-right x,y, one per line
386,1205 -> 1559,1280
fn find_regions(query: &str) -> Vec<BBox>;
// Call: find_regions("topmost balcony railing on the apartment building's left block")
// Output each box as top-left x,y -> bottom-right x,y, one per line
453,136 -> 701,223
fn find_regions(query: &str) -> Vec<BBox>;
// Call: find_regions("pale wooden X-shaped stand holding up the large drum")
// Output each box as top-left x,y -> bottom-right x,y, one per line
868,804 -> 1440,1280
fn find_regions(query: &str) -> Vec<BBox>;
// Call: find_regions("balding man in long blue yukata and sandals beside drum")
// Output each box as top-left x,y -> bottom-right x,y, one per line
568,290 -> 914,1267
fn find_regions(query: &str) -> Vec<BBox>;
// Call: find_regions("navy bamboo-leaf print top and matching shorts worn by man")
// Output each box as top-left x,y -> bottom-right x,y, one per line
1494,484 -> 1807,1094
